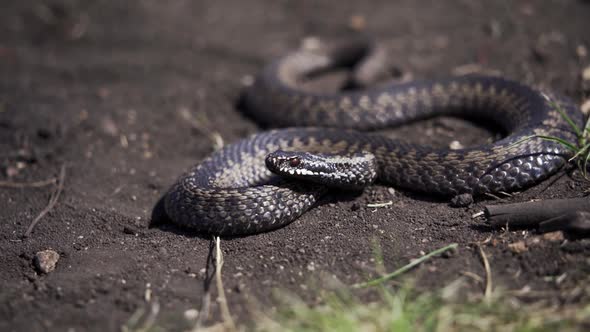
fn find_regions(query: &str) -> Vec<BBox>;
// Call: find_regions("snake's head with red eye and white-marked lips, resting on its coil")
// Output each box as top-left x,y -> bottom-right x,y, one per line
265,150 -> 377,190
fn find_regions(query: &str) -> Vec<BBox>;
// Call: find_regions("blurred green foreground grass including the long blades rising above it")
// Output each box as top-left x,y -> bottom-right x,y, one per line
254,243 -> 590,332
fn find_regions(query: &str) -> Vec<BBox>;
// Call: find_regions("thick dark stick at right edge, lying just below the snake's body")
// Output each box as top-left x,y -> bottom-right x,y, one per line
485,197 -> 590,227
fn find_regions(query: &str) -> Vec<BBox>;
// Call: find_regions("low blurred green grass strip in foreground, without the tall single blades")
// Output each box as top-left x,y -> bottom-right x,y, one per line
264,284 -> 590,332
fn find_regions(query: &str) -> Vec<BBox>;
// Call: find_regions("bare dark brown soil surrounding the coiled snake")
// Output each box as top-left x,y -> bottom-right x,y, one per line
0,0 -> 590,331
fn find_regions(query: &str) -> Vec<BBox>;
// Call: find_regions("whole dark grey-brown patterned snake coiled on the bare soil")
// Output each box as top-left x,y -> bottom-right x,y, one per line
164,39 -> 583,236
